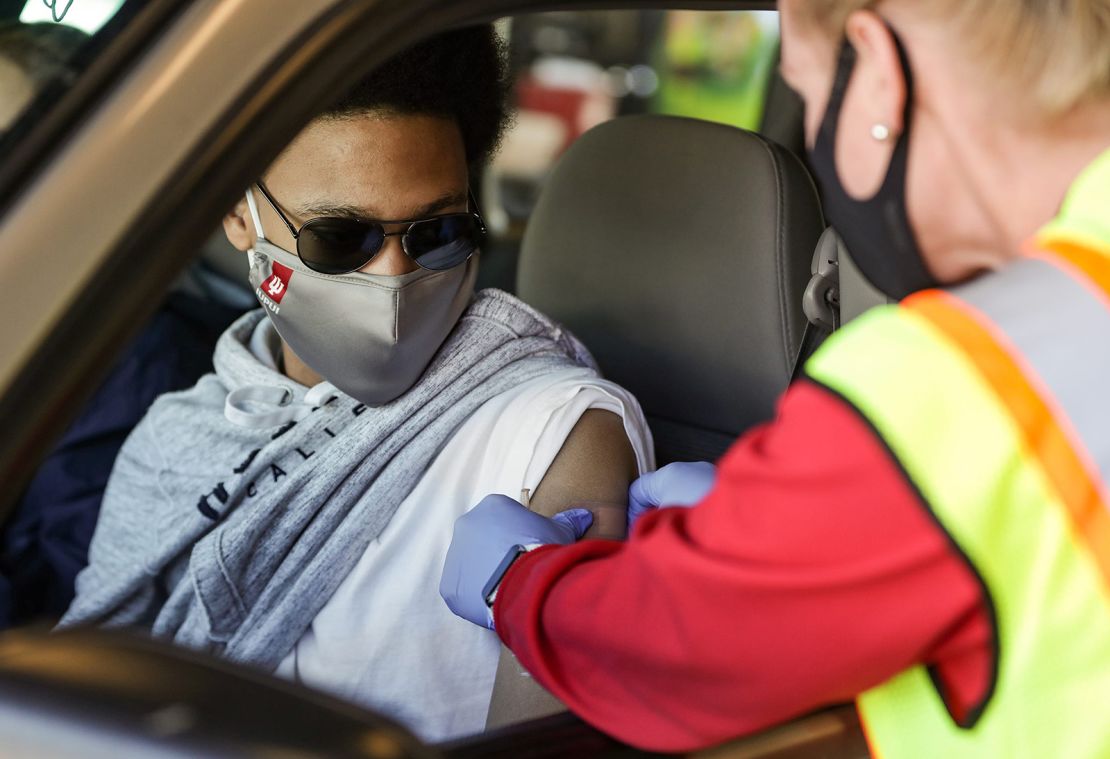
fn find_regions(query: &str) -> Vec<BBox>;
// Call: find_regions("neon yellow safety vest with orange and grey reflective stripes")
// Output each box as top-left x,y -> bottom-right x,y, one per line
806,151 -> 1110,759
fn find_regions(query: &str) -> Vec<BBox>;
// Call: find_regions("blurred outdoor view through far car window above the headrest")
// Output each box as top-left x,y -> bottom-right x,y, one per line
481,11 -> 779,291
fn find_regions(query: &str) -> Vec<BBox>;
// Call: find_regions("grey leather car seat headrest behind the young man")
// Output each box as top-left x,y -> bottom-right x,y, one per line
517,115 -> 824,463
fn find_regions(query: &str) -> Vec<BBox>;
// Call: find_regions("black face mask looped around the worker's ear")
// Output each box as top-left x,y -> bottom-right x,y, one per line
809,32 -> 937,300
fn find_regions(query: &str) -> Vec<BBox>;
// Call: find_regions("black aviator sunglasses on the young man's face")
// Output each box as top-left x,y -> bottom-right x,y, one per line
256,182 -> 486,274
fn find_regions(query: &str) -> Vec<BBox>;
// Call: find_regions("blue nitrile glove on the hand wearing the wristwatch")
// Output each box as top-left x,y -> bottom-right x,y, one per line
440,495 -> 594,630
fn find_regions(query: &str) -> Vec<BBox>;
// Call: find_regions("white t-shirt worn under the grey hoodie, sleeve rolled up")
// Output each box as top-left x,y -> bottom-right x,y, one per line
267,357 -> 654,741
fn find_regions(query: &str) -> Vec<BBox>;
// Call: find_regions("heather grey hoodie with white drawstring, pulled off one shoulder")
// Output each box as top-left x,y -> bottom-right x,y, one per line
59,290 -> 594,669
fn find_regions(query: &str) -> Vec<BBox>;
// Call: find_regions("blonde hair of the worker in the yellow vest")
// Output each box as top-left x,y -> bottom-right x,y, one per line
794,0 -> 1110,117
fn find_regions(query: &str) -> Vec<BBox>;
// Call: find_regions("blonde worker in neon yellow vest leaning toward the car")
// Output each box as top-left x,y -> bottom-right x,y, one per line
441,0 -> 1110,759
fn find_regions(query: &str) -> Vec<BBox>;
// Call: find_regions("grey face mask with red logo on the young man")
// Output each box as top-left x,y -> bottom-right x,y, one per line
246,192 -> 477,406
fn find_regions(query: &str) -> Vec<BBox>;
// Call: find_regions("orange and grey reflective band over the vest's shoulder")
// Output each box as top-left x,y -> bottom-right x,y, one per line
919,257 -> 1110,585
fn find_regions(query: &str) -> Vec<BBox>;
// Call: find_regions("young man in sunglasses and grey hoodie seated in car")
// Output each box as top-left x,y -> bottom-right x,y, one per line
62,28 -> 652,739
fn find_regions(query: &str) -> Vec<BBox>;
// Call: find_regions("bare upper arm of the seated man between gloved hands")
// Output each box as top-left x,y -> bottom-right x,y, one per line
528,408 -> 638,538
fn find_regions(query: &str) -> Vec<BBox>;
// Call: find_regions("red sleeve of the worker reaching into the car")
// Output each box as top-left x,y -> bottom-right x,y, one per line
494,382 -> 991,751
